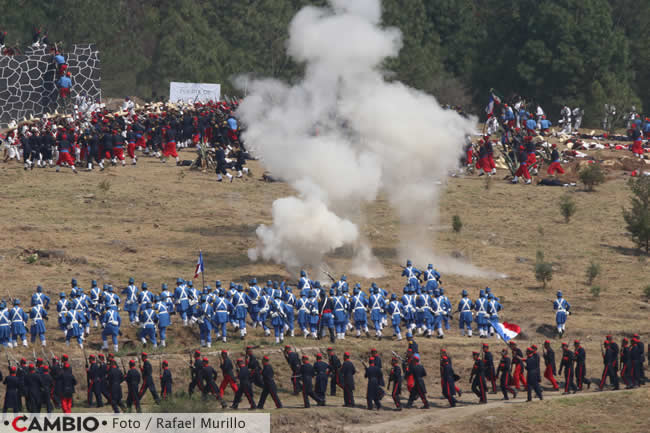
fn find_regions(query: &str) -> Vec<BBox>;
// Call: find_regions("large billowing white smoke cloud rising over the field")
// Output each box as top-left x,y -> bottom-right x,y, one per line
238,0 -> 474,277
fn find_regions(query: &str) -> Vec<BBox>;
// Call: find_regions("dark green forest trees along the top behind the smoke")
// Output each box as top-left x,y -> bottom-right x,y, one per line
0,0 -> 650,126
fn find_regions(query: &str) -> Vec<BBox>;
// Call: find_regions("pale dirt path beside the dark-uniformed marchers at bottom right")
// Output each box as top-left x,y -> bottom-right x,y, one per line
344,384 -> 636,433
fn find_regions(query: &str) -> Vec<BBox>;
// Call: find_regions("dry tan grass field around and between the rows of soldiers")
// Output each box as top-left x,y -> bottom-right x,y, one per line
0,143 -> 650,432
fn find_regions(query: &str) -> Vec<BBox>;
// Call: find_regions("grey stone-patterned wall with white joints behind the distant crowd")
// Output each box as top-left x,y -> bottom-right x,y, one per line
0,44 -> 101,125
